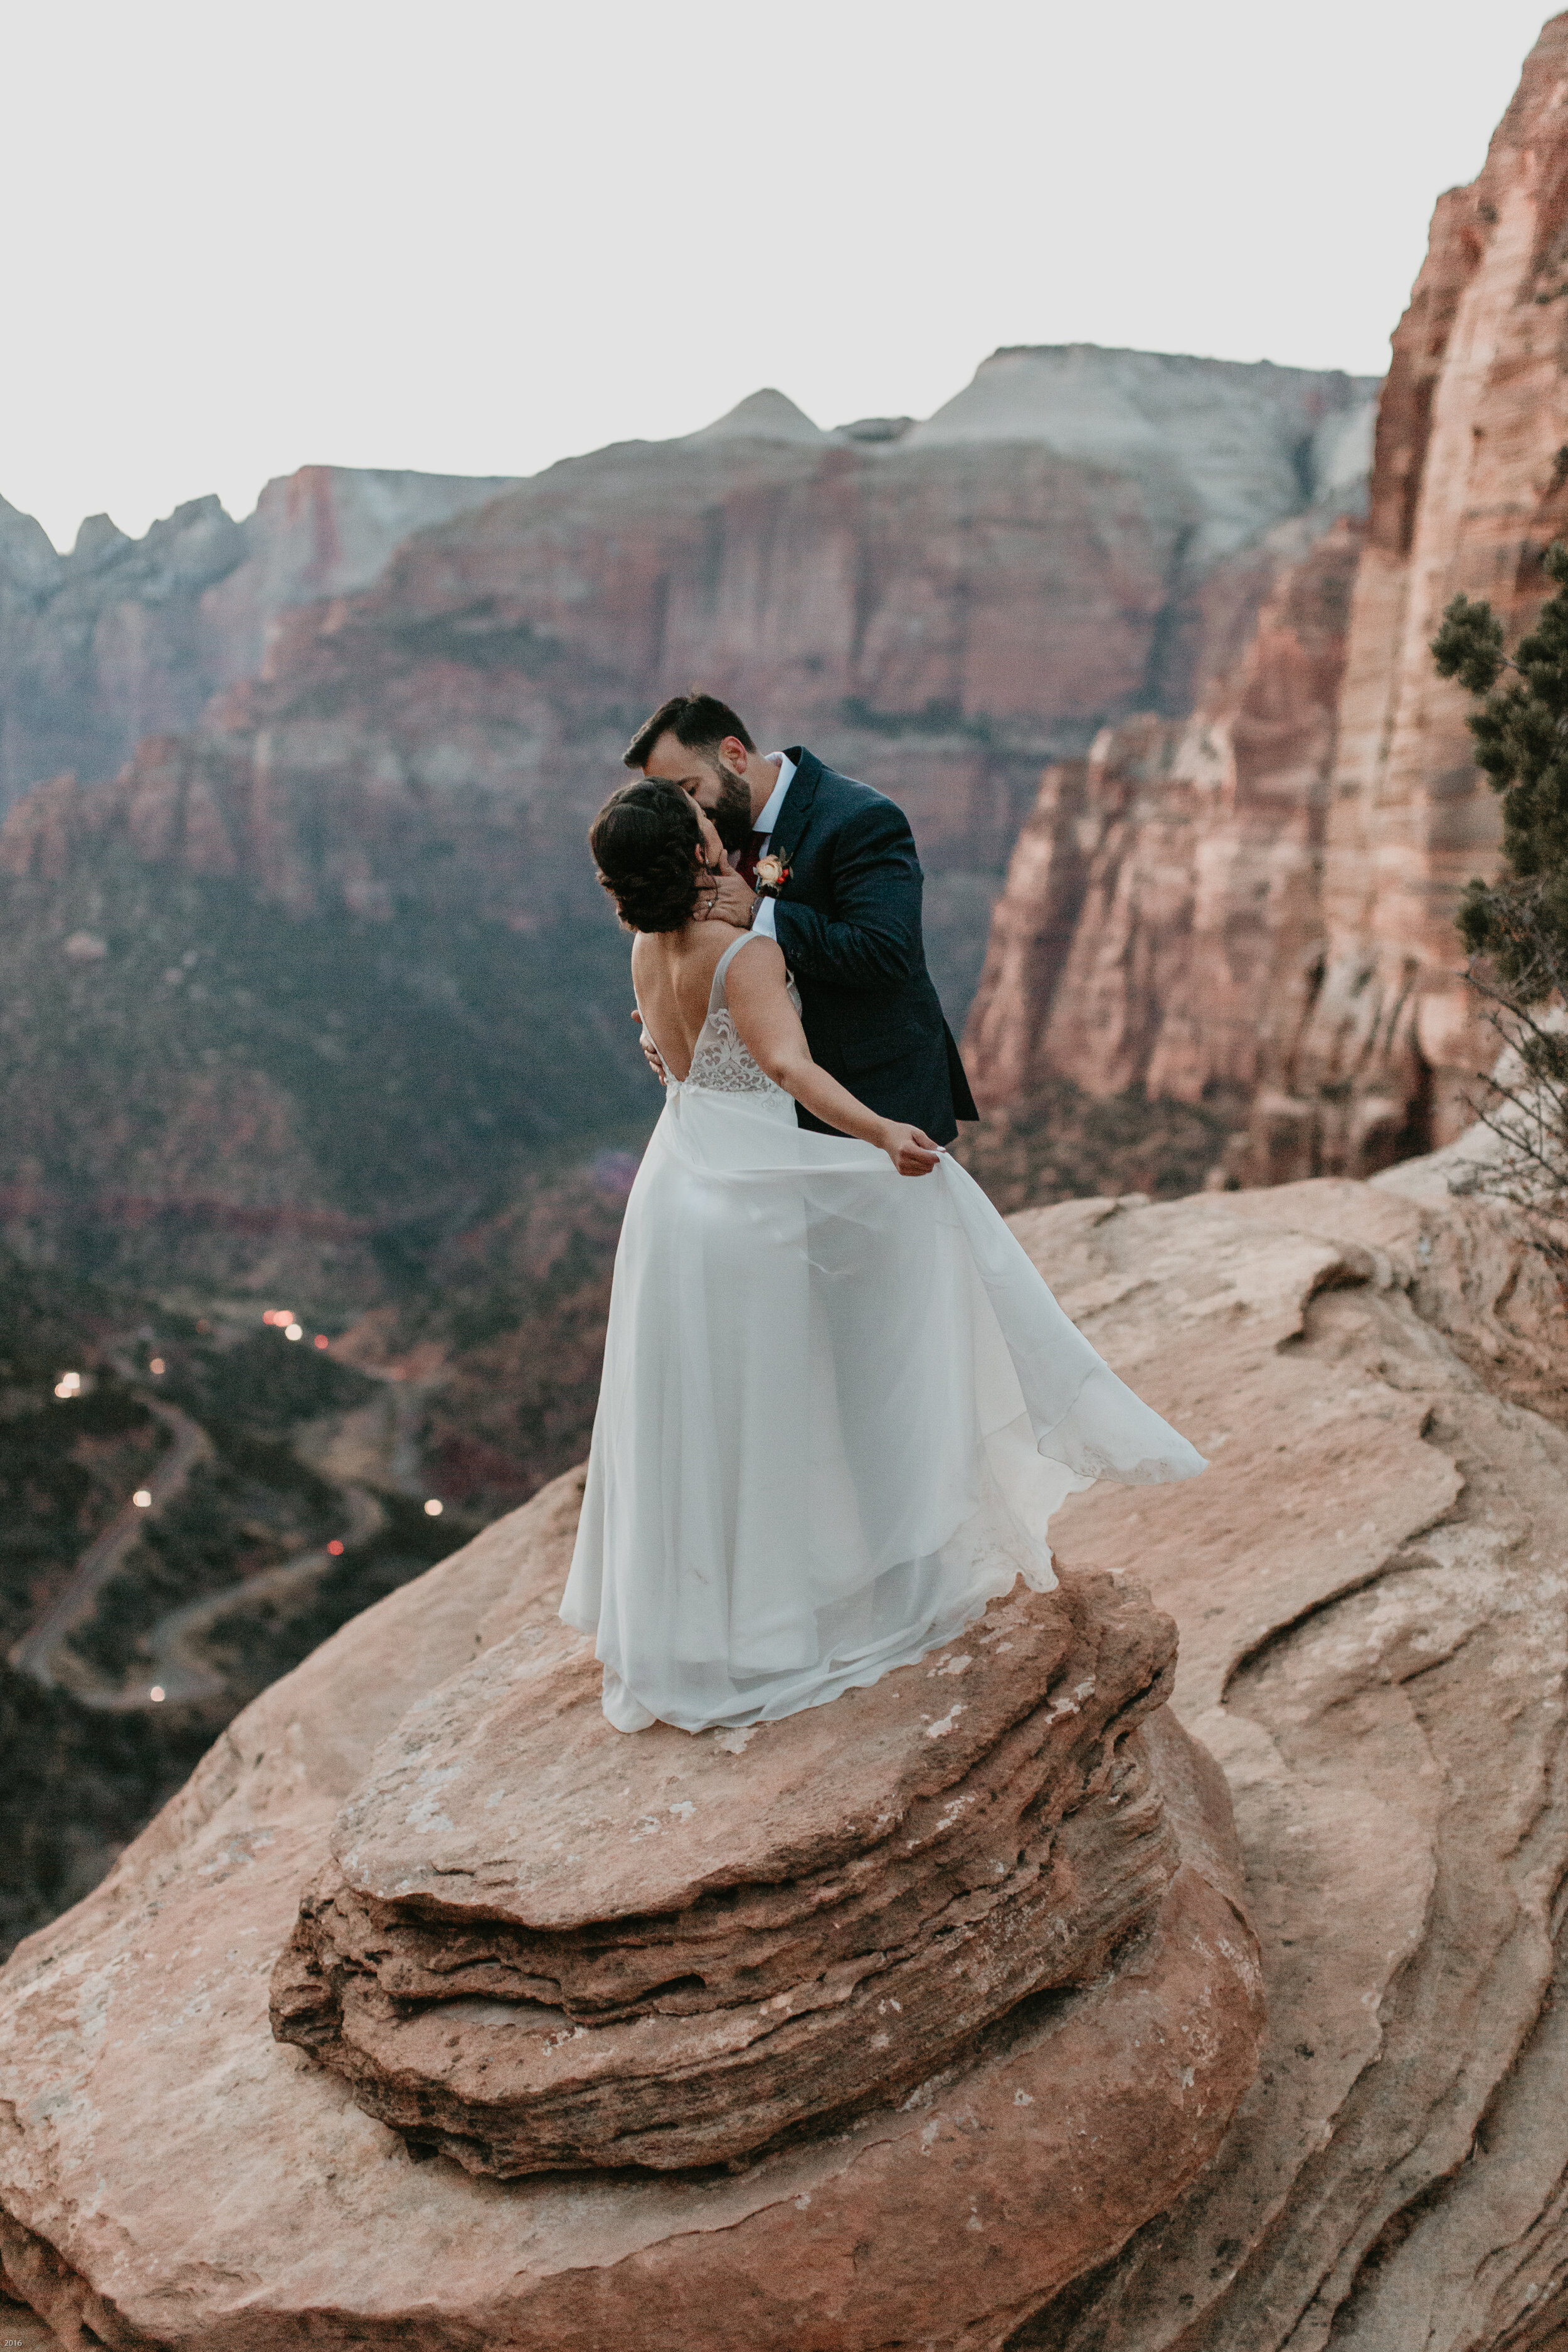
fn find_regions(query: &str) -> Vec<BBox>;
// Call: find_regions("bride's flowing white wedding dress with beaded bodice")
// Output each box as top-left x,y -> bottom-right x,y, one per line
562,938 -> 1204,1731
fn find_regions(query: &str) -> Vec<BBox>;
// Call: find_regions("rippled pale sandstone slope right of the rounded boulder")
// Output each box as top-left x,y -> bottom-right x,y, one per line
1015,1167 -> 1568,2352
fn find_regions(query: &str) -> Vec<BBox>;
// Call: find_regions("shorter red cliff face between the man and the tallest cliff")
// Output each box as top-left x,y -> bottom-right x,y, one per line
964,520 -> 1361,1113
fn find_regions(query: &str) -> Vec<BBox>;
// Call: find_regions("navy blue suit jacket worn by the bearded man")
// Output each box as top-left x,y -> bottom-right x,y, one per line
769,748 -> 980,1143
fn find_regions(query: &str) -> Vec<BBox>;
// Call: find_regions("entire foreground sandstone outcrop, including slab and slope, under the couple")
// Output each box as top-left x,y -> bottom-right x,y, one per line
0,1167 -> 1568,2352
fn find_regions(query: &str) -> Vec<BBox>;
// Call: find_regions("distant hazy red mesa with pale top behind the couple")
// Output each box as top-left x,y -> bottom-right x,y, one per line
3,346 -> 1373,1014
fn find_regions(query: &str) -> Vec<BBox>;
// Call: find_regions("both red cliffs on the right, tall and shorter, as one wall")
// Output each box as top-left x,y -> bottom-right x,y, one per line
966,16 -> 1568,1183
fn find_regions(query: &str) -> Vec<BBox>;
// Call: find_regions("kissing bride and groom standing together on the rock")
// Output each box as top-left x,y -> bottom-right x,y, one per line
559,692 -> 1206,1731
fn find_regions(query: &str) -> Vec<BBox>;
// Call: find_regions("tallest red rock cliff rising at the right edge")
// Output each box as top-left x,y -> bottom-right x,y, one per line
1251,14 -> 1568,1181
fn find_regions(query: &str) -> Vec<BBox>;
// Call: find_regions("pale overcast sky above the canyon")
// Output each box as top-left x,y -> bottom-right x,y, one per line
0,0 -> 1542,546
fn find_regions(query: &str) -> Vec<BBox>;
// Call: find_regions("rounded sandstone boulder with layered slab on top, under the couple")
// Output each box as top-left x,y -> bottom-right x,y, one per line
0,1477 -> 1263,2352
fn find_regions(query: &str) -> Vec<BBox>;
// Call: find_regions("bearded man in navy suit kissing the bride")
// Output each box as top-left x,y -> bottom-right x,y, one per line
625,694 -> 980,1143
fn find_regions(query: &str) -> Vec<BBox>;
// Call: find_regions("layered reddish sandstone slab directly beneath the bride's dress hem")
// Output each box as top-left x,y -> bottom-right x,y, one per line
273,1586 -> 1180,2176
